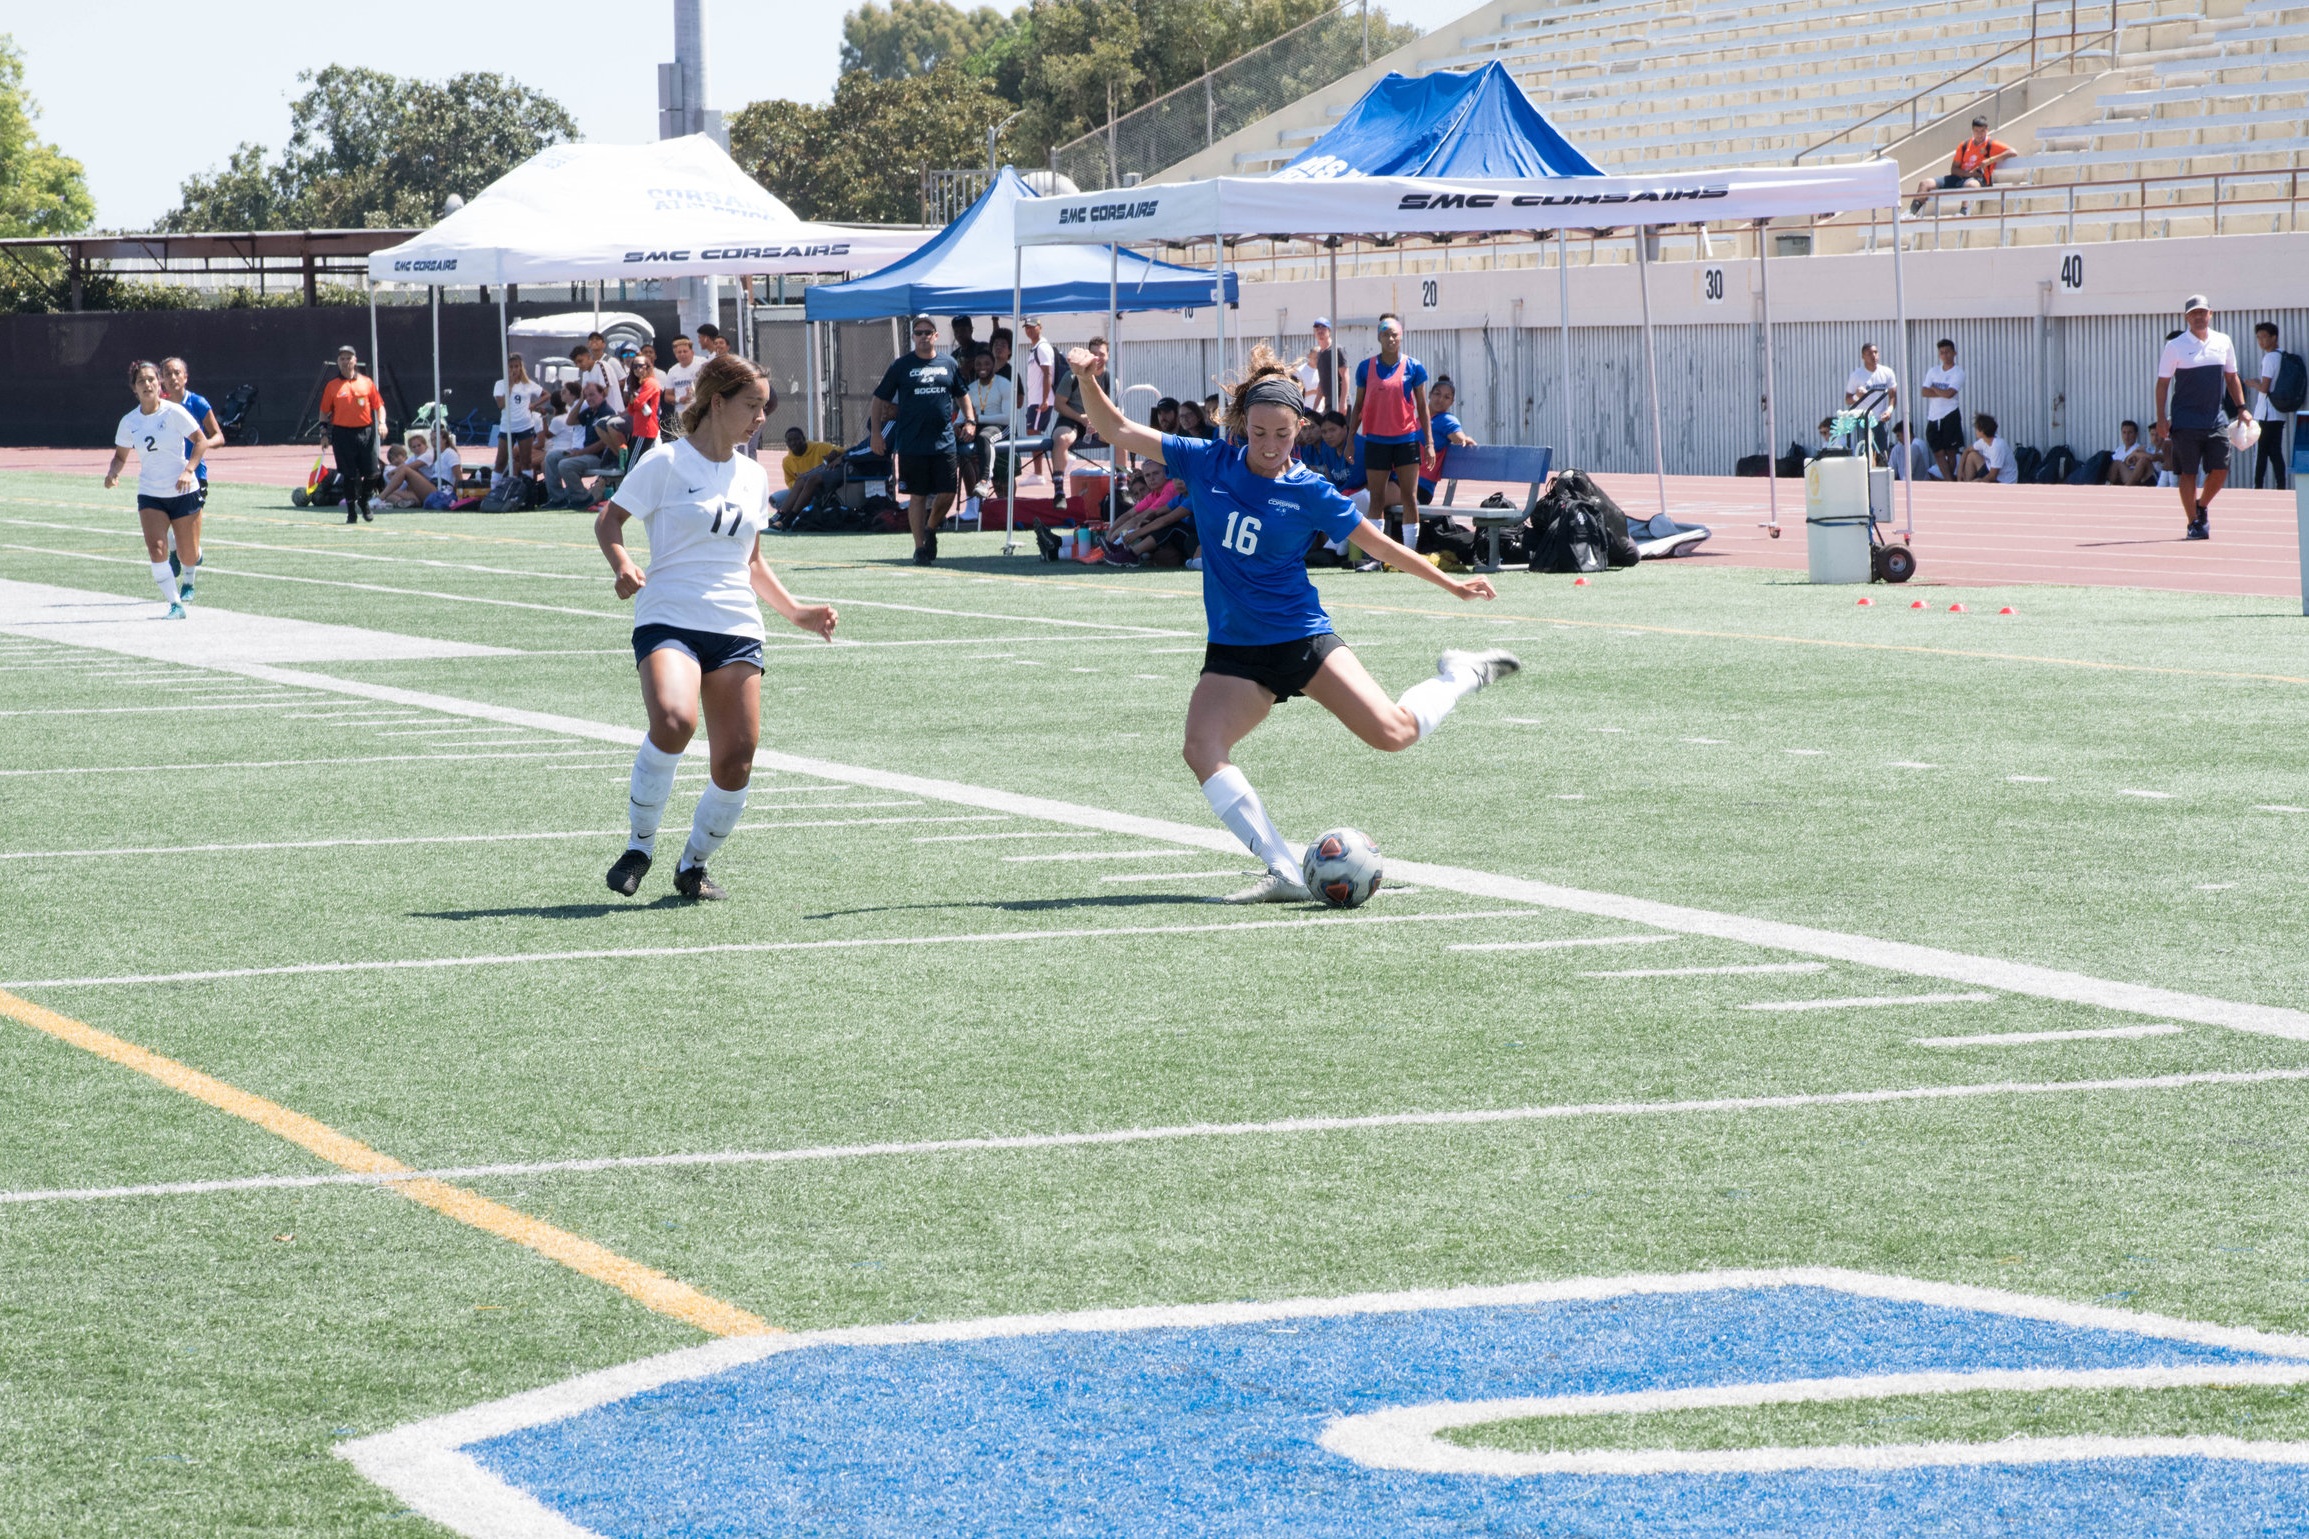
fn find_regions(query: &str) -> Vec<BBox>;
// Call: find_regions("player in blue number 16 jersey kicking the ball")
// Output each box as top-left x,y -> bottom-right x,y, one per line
1067,344 -> 1522,902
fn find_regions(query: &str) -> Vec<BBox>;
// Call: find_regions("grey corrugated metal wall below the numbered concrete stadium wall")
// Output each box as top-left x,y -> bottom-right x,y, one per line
1103,309 -> 2309,475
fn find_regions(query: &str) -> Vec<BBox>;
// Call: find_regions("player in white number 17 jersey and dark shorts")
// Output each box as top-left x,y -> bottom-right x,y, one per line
593,353 -> 836,900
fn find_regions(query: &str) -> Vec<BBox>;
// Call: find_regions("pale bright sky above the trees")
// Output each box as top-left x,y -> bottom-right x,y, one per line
0,0 -> 1473,231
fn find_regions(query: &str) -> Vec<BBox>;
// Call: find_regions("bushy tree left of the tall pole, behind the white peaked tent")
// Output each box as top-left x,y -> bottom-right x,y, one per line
162,65 -> 577,231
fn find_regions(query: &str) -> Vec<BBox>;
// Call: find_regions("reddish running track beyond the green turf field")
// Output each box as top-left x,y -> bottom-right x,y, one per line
0,445 -> 2302,598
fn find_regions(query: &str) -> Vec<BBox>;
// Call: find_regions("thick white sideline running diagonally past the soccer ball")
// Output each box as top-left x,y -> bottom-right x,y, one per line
31,646 -> 2309,1041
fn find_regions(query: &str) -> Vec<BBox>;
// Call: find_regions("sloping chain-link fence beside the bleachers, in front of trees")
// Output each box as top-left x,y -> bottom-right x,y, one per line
1051,0 -> 1415,192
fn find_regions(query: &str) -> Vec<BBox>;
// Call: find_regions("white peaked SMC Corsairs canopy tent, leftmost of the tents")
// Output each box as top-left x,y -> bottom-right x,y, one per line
369,134 -> 937,452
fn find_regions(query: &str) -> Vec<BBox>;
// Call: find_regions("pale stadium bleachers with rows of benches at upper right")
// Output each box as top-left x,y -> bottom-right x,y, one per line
1231,0 -> 2309,245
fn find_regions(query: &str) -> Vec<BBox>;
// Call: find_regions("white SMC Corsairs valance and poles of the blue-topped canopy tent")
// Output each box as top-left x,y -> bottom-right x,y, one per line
1018,162 -> 1914,533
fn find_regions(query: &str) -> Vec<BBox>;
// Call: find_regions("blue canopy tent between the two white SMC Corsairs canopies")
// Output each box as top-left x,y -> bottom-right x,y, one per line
801,166 -> 1240,554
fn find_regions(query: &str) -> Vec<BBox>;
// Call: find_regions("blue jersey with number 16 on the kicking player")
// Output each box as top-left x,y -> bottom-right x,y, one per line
1161,434 -> 1362,646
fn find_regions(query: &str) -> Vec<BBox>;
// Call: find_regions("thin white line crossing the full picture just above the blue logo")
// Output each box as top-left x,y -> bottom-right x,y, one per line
18,1068 -> 2309,1204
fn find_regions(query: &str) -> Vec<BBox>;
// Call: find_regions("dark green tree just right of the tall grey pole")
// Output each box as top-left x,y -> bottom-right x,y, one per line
730,65 -> 1011,224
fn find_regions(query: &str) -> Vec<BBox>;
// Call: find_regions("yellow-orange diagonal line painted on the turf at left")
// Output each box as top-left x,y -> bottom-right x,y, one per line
0,990 -> 778,1336
